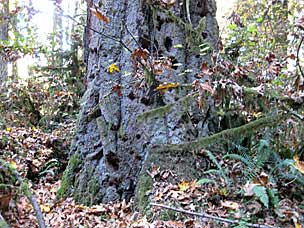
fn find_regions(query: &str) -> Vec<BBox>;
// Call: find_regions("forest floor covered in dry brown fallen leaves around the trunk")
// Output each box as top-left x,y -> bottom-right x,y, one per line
0,121 -> 304,228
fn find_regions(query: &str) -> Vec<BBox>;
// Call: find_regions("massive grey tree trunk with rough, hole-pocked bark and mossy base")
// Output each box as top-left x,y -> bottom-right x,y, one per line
59,0 -> 218,208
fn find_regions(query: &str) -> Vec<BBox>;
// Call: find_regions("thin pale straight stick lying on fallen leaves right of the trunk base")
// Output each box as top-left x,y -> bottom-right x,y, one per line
151,203 -> 274,228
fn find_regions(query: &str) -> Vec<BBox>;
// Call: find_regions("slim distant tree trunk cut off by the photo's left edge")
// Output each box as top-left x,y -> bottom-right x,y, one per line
0,0 -> 9,85
